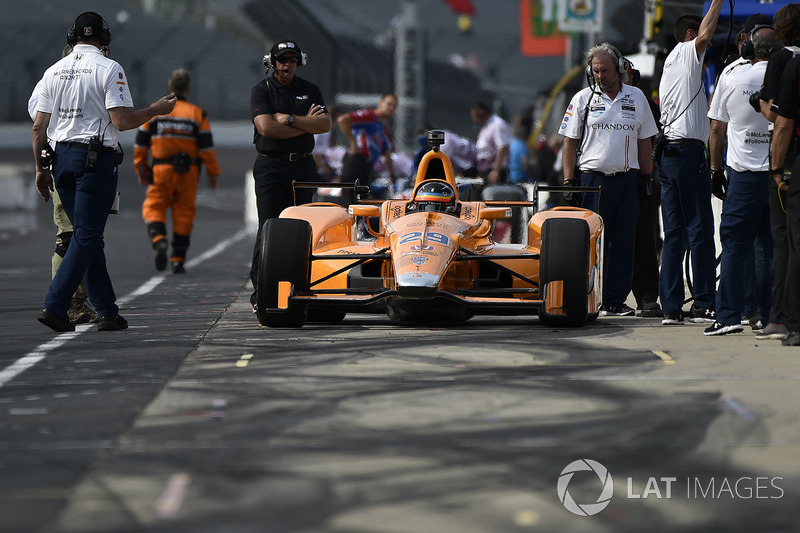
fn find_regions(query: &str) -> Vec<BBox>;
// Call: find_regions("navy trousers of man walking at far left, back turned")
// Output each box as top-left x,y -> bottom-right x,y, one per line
44,145 -> 119,317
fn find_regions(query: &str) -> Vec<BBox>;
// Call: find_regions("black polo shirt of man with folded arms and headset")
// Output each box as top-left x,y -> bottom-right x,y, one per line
250,73 -> 325,154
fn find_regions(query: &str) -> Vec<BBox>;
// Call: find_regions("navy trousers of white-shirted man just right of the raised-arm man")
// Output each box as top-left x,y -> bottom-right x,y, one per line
717,170 -> 772,326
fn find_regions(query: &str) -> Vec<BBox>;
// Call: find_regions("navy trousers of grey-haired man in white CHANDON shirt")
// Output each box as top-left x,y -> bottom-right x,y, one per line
581,170 -> 639,306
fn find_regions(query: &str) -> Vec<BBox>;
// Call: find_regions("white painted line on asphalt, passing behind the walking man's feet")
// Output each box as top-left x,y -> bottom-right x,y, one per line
0,228 -> 250,388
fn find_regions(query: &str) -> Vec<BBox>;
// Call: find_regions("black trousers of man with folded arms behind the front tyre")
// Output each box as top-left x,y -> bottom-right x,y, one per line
250,154 -> 317,304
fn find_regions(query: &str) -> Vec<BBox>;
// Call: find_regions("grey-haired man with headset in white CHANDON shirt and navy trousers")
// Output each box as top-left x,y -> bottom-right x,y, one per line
561,43 -> 658,316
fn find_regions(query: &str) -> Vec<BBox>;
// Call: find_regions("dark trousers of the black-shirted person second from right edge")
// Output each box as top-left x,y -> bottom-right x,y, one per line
769,179 -> 789,324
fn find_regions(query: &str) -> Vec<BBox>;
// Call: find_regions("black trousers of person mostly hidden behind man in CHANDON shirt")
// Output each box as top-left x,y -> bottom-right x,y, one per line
632,180 -> 661,307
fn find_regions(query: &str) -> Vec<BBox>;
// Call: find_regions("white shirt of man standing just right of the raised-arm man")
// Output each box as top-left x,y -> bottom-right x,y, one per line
708,61 -> 770,172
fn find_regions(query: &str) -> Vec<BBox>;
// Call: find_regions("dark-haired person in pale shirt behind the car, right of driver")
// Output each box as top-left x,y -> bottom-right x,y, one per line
470,102 -> 511,185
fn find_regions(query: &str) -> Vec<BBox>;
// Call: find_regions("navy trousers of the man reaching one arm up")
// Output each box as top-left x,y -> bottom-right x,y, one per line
657,143 -> 717,314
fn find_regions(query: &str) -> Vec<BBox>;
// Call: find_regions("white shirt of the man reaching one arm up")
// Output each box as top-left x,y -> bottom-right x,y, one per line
658,40 -> 711,142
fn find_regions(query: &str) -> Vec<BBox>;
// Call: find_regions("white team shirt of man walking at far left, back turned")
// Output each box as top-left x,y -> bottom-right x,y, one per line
36,44 -> 133,147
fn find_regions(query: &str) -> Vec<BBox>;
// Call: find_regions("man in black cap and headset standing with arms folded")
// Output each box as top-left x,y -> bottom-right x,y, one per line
250,39 -> 331,310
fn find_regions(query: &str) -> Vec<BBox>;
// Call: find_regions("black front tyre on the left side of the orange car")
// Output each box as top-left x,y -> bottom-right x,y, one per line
256,218 -> 312,328
